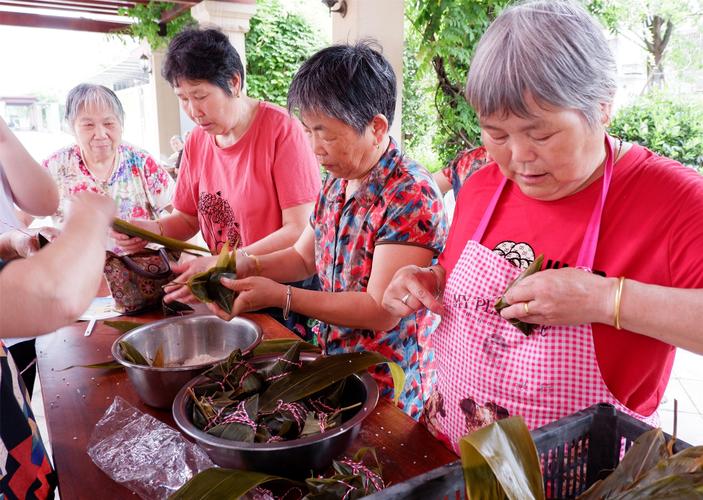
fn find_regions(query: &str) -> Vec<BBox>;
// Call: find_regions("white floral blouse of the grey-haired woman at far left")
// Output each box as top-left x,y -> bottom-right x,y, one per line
44,143 -> 176,252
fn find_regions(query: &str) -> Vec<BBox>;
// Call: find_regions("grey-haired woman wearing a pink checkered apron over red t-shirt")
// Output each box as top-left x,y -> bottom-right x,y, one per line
384,0 -> 703,454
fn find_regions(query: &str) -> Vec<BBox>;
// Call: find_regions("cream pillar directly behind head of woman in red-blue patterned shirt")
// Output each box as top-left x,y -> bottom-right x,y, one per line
332,0 -> 404,142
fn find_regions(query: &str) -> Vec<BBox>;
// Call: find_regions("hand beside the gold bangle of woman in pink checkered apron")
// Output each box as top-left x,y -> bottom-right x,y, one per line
501,267 -> 617,325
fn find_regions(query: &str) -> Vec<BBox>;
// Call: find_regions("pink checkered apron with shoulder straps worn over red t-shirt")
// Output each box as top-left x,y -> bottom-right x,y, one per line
424,136 -> 658,452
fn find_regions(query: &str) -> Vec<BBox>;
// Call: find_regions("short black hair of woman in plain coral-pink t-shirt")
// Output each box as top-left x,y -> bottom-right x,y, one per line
161,28 -> 244,96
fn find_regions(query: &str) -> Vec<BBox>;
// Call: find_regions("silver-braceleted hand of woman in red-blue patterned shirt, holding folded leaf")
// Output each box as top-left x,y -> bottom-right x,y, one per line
207,276 -> 286,321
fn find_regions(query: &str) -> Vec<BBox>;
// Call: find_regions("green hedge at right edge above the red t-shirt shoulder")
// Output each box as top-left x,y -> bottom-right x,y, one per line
610,94 -> 703,172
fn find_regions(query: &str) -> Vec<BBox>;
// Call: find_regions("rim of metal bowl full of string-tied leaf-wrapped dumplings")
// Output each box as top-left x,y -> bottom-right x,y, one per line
172,352 -> 379,451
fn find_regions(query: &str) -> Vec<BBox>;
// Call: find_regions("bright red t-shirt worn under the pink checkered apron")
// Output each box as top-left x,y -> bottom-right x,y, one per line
440,145 -> 703,415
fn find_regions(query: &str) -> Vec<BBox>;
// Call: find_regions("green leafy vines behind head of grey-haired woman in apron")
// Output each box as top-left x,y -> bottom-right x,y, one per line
403,0 -> 622,165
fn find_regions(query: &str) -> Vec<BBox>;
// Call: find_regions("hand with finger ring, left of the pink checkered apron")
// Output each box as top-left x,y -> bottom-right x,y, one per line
383,265 -> 444,317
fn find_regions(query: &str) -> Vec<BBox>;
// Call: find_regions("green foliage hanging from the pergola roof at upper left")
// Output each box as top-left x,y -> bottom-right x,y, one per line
118,0 -> 195,50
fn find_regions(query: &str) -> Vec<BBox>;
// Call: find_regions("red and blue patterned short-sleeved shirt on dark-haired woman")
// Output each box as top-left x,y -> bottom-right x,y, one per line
311,141 -> 447,419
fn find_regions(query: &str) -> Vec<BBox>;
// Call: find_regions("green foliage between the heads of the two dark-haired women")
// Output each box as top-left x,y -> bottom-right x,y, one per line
246,0 -> 321,106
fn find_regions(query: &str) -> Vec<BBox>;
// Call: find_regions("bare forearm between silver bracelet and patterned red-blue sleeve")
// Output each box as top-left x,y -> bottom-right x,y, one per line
290,288 -> 398,331
